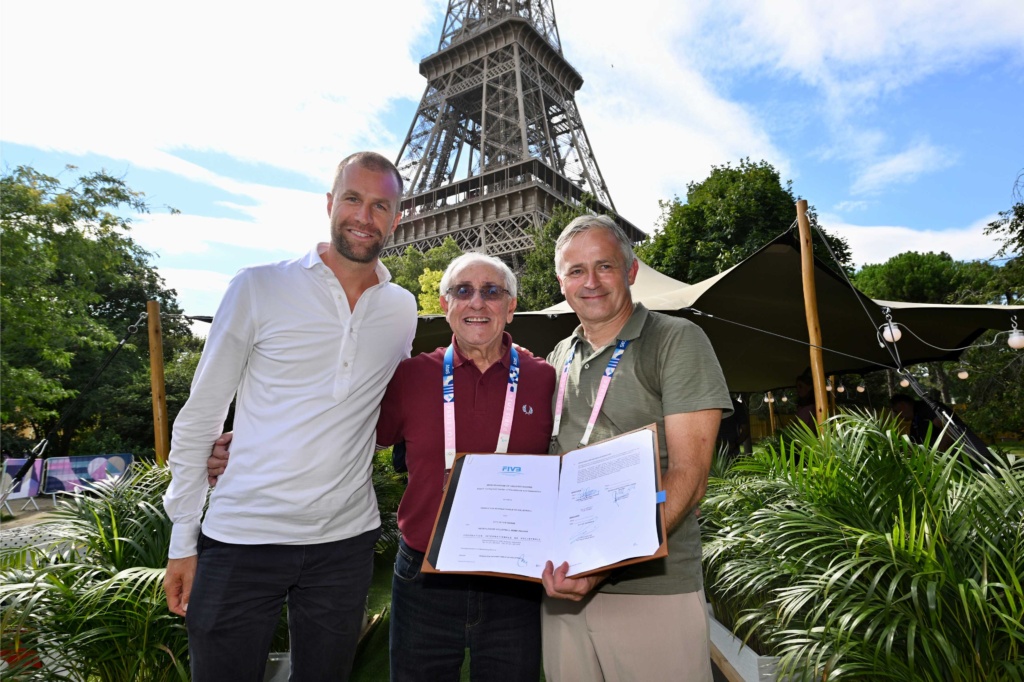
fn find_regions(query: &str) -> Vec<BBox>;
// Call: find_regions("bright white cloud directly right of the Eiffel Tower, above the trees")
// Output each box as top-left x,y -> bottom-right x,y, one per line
557,0 -> 790,232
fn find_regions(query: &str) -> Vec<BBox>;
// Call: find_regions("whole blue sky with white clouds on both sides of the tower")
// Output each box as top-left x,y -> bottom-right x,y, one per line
0,0 -> 1024,314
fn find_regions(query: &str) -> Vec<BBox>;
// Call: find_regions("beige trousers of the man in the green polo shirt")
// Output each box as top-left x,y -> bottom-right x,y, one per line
541,592 -> 712,682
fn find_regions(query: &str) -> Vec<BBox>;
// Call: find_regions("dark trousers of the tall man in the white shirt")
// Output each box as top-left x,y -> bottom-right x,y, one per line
185,528 -> 380,682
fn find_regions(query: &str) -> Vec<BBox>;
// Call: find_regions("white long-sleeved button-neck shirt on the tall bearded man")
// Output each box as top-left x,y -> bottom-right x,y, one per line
164,244 -> 417,559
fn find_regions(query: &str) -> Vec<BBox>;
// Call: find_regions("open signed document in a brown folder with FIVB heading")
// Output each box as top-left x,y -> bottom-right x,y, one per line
424,425 -> 667,580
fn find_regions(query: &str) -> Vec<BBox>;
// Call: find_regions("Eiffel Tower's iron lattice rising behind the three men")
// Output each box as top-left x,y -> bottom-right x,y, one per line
383,0 -> 644,264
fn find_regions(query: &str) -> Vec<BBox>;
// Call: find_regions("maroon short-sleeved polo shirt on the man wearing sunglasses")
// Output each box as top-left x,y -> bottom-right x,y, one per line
377,332 -> 555,552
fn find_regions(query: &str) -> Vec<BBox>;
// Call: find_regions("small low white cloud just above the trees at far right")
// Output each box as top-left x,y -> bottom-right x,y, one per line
818,213 -> 999,267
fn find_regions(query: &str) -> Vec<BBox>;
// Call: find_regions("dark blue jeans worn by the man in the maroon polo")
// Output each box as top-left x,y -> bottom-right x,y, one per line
391,541 -> 541,682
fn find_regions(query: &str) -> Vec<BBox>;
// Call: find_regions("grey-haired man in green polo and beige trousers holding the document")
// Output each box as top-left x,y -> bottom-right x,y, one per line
542,215 -> 732,682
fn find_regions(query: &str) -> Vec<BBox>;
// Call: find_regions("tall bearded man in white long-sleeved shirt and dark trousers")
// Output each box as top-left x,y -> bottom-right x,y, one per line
164,152 -> 416,682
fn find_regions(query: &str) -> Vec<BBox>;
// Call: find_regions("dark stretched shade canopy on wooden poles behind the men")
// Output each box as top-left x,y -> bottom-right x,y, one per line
413,232 -> 1024,392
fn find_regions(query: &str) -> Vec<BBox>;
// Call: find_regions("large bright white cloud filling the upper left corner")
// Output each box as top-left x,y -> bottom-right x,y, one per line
0,0 -> 439,183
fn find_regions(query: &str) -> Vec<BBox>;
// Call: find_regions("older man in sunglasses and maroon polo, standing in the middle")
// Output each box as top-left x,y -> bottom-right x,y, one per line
377,253 -> 555,682
